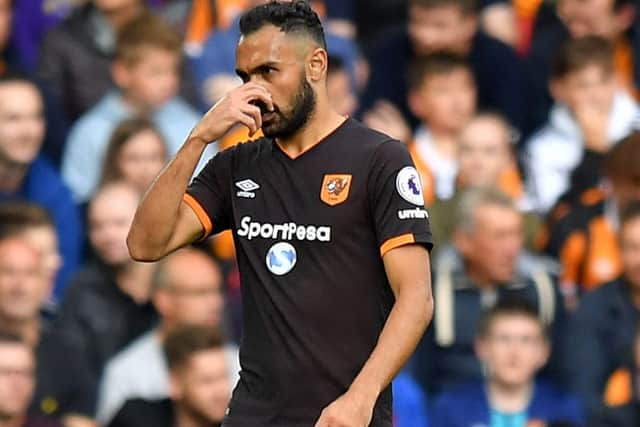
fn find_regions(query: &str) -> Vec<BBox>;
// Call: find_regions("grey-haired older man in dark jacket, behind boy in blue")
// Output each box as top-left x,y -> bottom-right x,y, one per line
413,189 -> 563,395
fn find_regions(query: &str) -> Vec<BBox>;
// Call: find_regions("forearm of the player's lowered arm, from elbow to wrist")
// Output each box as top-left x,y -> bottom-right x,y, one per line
349,283 -> 433,399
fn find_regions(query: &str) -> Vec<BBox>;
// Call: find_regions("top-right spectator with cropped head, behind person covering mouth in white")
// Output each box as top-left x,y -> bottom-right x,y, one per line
527,0 -> 640,132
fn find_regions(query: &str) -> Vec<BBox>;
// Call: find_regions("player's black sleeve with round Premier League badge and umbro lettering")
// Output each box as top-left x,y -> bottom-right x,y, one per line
368,141 -> 433,256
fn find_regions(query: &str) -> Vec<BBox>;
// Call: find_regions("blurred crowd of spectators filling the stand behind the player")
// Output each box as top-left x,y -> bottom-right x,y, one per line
0,0 -> 640,427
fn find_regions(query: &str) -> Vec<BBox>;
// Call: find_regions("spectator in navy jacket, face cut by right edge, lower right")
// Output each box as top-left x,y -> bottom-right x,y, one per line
565,201 -> 640,427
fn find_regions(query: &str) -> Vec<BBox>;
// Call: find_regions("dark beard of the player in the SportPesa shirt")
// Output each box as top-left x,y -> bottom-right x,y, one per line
262,75 -> 316,139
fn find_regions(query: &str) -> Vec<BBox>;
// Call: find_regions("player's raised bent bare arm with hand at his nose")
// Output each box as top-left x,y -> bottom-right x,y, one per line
127,83 -> 273,261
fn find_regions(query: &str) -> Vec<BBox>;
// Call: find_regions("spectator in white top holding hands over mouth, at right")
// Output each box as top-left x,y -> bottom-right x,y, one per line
526,36 -> 640,213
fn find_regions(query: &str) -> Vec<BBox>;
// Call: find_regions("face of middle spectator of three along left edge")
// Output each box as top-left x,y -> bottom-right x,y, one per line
0,239 -> 49,322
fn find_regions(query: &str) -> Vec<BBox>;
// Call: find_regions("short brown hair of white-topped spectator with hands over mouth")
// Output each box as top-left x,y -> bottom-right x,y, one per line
551,36 -> 615,79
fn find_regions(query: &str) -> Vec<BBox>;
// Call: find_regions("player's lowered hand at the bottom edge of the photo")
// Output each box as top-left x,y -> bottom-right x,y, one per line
315,390 -> 375,427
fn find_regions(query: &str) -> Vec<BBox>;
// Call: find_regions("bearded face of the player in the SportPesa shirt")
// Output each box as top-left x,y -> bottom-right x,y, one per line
236,25 -> 318,138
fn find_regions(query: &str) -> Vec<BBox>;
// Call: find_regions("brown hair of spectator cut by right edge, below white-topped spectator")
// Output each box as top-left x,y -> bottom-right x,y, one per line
604,130 -> 640,187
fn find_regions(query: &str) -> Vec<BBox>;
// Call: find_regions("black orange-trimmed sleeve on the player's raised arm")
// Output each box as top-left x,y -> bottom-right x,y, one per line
183,148 -> 234,239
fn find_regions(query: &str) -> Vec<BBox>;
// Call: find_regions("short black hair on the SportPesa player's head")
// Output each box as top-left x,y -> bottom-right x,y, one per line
240,0 -> 327,49
